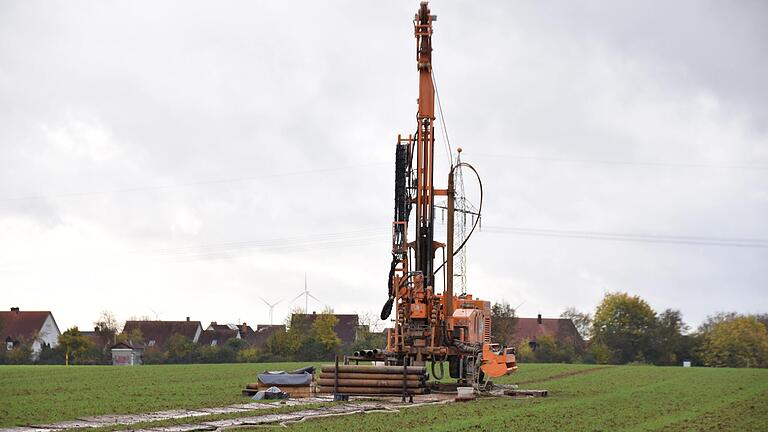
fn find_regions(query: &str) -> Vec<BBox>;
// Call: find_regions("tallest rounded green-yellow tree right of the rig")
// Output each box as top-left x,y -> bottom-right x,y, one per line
593,293 -> 656,363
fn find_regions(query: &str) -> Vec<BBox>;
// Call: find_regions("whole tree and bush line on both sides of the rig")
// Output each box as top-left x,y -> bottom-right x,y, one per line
0,293 -> 768,367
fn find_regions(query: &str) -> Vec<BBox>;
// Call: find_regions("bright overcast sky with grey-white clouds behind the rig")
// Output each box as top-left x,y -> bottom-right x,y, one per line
0,0 -> 768,330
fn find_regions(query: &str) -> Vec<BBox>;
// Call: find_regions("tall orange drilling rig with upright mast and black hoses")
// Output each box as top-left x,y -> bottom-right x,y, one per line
381,2 -> 517,383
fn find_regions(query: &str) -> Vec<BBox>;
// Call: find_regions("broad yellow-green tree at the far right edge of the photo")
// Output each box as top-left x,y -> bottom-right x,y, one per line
702,316 -> 768,367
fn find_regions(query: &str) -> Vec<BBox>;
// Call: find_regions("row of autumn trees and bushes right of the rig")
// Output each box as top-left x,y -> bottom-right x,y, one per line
492,293 -> 768,367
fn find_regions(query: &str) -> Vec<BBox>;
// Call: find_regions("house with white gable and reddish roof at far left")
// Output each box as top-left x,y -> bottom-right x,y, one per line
0,307 -> 61,357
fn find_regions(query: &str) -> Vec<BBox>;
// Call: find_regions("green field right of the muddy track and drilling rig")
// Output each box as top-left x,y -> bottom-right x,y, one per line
260,364 -> 768,432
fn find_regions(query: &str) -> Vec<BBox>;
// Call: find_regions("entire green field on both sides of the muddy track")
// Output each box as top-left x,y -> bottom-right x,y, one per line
0,364 -> 768,431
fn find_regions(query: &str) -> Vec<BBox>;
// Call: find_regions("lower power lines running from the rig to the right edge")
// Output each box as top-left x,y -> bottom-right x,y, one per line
482,226 -> 768,248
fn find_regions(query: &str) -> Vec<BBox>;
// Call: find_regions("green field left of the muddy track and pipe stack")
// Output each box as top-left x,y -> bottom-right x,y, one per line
0,363 -> 316,427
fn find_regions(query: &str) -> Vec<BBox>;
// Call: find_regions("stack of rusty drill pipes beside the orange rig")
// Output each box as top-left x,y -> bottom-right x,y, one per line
317,365 -> 427,395
